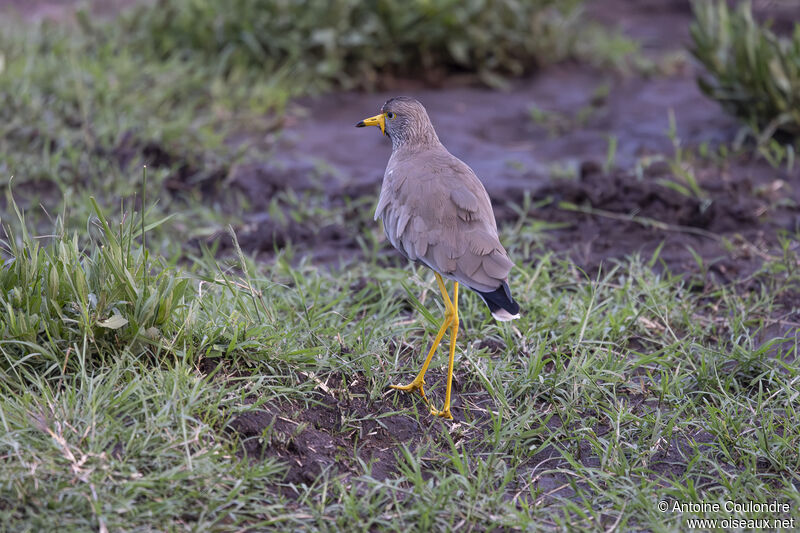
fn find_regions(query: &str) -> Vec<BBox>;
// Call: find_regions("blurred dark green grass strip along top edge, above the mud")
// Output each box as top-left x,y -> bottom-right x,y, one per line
115,0 -> 580,90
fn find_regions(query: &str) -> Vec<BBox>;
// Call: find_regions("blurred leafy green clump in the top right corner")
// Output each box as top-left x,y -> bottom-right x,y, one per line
691,0 -> 800,140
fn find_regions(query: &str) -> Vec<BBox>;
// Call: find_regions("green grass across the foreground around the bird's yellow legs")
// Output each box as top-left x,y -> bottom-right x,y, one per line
0,193 -> 800,531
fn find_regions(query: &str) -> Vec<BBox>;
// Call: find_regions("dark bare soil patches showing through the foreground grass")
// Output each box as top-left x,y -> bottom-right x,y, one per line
220,364 -> 737,501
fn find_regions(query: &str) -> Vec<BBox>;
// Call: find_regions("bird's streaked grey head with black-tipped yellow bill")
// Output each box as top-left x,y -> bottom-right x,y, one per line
356,96 -> 439,148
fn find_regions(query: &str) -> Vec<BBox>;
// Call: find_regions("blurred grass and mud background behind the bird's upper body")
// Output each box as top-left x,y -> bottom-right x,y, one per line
0,0 -> 800,269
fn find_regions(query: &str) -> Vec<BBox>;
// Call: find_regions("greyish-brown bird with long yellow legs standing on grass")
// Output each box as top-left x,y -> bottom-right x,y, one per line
356,96 -> 520,420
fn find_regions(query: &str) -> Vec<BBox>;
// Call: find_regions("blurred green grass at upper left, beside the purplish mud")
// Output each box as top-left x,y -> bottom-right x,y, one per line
0,16 -> 289,248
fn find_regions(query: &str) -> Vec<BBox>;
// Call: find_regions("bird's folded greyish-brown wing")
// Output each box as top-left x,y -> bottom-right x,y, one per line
375,152 -> 513,291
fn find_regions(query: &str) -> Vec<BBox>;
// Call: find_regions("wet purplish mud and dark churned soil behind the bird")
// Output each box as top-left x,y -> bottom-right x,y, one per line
231,0 -> 800,282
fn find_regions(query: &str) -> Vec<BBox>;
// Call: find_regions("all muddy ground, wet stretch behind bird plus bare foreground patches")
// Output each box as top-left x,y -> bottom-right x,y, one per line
6,0 -> 800,502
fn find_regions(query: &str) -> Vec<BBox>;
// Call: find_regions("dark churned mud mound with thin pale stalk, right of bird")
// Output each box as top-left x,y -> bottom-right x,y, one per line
520,154 -> 800,276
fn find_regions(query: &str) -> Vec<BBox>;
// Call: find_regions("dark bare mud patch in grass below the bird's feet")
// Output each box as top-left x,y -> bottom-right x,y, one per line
227,368 -> 484,488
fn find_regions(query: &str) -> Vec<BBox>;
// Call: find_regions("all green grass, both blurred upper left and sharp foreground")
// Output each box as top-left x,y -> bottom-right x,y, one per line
0,2 -> 800,531
